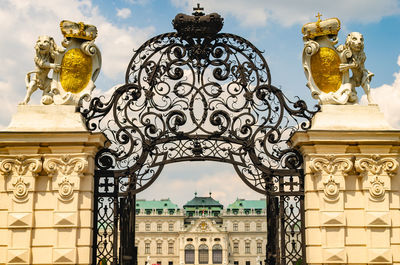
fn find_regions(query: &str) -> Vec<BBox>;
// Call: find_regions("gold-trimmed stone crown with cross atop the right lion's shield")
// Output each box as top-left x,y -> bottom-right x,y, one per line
301,13 -> 340,39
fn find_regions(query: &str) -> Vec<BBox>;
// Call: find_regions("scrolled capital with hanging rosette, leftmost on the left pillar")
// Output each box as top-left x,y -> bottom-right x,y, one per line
0,156 -> 42,202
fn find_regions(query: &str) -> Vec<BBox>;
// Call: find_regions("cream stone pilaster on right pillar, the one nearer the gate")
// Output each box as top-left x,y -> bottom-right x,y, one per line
306,154 -> 353,263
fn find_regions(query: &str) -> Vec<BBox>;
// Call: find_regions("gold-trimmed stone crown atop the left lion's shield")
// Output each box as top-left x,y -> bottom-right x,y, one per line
60,20 -> 97,40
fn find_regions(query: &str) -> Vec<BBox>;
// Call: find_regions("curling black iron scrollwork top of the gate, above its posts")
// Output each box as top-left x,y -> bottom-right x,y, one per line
81,10 -> 318,194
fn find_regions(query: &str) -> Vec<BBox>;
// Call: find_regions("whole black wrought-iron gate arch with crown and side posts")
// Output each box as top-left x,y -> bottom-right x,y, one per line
81,9 -> 318,264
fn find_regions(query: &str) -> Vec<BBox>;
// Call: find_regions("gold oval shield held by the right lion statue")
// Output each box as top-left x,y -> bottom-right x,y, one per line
311,47 -> 342,93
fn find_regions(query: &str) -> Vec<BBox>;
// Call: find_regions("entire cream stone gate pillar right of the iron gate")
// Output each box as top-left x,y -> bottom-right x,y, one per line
291,105 -> 400,264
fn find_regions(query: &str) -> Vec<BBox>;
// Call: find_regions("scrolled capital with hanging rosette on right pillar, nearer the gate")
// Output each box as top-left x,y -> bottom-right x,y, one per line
310,155 -> 353,201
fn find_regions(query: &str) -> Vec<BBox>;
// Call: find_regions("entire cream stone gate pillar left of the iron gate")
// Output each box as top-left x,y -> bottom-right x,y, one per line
0,106 -> 105,264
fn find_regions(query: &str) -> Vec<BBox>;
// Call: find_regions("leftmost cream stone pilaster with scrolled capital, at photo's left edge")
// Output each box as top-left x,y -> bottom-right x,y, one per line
0,155 -> 42,264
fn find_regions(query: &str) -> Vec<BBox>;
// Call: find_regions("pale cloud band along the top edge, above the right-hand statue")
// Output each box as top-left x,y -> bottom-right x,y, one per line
171,0 -> 400,26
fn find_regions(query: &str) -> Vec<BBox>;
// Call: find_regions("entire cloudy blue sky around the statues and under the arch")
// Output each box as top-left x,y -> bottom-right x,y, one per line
0,0 -> 400,205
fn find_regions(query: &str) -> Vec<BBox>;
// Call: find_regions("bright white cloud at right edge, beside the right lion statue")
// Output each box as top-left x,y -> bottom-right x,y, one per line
360,56 -> 400,129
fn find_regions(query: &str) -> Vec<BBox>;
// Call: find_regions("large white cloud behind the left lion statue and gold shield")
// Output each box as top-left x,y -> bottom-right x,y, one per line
0,0 -> 154,127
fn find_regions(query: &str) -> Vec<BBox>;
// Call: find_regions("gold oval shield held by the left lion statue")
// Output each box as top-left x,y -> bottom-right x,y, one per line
60,48 -> 92,94
